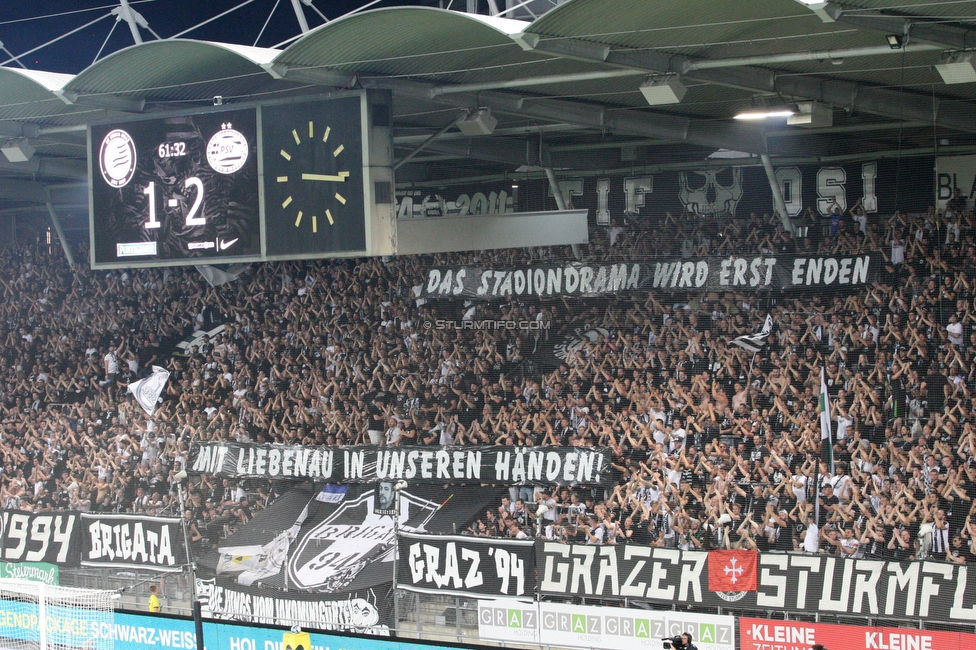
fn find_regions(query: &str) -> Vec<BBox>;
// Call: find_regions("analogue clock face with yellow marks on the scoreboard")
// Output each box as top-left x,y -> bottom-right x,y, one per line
261,97 -> 366,258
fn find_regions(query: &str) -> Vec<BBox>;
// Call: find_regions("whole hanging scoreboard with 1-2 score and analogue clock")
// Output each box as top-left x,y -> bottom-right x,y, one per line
88,92 -> 394,268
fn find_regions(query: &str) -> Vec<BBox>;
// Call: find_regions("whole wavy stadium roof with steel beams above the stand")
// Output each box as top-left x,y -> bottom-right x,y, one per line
0,0 -> 976,244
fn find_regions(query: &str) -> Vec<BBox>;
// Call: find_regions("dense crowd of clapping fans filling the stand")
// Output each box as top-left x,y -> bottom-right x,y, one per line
0,204 -> 976,562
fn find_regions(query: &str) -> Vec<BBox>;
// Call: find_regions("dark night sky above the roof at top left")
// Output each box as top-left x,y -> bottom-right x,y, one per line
0,0 -> 438,74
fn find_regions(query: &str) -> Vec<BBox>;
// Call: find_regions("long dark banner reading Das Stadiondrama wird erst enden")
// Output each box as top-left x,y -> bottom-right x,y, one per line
417,253 -> 884,300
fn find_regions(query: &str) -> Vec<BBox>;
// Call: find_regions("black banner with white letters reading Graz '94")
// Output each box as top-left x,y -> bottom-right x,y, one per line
397,533 -> 536,598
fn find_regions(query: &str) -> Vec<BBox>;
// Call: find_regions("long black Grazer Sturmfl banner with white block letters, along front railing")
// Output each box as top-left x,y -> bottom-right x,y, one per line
536,542 -> 976,624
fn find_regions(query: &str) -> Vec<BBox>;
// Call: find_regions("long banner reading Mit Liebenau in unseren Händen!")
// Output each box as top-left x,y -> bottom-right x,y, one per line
190,442 -> 613,485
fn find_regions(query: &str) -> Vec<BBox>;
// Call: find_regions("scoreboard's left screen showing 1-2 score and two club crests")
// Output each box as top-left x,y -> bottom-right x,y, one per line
90,108 -> 261,267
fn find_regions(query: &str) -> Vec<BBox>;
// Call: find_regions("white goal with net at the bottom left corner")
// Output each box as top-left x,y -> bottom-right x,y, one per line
0,580 -> 118,650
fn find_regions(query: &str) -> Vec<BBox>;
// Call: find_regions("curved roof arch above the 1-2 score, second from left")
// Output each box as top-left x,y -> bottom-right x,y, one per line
64,39 -> 279,101
